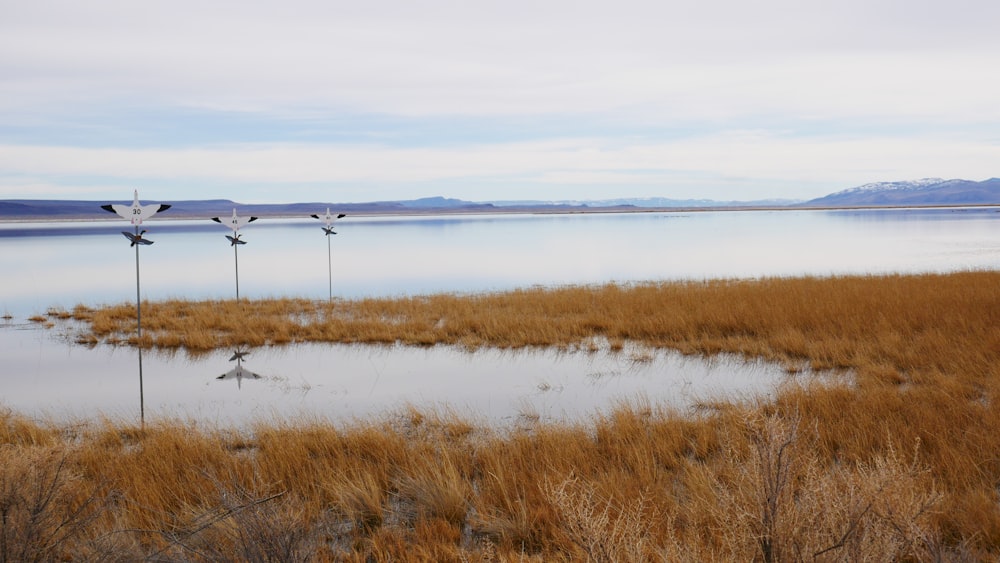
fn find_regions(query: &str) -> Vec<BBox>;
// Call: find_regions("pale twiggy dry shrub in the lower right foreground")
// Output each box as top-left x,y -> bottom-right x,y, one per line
685,413 -> 942,562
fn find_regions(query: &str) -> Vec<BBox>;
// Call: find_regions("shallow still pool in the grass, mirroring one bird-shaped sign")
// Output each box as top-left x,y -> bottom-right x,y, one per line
0,323 -> 804,425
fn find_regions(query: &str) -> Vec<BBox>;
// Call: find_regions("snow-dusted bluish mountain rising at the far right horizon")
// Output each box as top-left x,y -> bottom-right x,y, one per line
803,178 -> 1000,207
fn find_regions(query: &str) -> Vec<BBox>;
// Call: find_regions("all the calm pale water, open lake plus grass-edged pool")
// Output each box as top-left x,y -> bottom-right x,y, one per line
0,208 -> 1000,423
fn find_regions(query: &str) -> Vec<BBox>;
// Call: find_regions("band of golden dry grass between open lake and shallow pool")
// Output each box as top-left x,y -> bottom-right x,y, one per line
79,272 -> 1000,380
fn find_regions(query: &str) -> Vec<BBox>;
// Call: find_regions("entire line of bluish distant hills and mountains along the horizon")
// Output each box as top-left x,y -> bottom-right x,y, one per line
0,178 -> 1000,219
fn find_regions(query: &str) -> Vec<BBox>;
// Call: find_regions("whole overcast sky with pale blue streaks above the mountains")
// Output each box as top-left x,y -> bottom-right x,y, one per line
0,0 -> 1000,203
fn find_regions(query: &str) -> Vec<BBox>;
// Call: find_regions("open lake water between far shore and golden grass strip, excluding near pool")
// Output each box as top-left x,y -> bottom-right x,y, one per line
0,208 -> 1000,317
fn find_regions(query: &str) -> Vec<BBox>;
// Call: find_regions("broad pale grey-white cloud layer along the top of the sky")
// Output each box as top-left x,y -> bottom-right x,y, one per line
0,1 -> 1000,119
